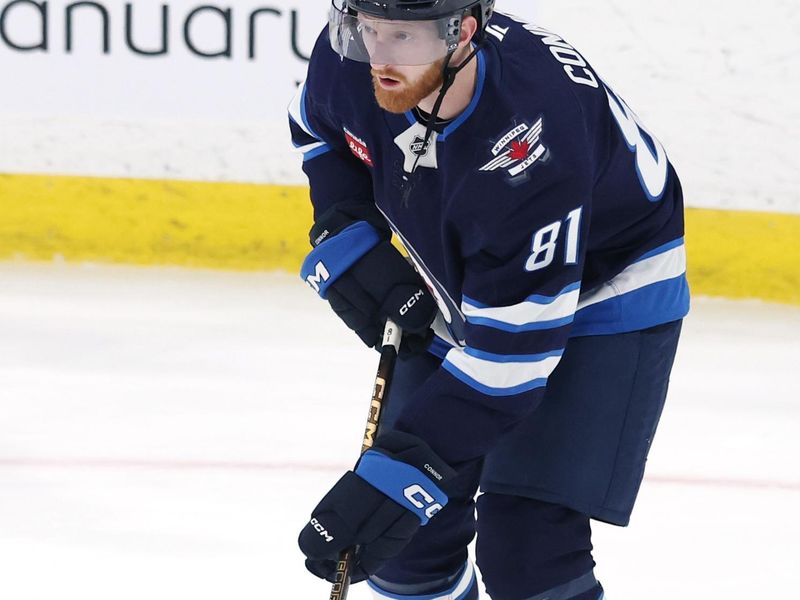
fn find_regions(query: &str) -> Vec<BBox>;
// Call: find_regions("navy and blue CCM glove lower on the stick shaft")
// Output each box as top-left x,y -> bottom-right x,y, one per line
299,432 -> 455,583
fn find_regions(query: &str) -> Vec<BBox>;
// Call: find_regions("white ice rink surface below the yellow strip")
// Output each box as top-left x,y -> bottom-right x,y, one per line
0,264 -> 800,600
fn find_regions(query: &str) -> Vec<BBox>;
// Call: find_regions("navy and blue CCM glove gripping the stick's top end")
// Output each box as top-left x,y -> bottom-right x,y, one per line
302,207 -> 438,352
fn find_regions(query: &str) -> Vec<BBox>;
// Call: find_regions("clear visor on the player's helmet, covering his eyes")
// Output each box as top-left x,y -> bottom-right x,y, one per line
329,0 -> 459,66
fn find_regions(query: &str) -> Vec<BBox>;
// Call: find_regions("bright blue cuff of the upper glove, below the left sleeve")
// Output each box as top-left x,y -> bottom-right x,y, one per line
300,221 -> 381,298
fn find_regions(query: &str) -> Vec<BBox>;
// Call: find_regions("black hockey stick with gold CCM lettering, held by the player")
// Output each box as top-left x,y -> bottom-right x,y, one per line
330,319 -> 403,600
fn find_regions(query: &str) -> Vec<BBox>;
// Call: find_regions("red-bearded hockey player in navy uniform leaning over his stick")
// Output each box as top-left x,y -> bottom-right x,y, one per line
290,0 -> 689,600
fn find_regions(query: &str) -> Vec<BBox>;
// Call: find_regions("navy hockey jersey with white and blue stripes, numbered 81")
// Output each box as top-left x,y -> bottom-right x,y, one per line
290,14 -> 689,463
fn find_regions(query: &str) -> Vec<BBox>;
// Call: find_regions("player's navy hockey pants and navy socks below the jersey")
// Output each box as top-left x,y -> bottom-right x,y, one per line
373,321 -> 681,600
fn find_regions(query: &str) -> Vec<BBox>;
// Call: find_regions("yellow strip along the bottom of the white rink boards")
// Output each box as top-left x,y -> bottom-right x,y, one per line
0,175 -> 800,304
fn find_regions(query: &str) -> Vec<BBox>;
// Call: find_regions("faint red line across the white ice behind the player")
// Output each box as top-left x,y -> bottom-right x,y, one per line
0,458 -> 800,492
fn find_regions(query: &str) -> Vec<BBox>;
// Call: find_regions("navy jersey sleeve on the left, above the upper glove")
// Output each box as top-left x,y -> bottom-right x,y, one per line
289,32 -> 374,219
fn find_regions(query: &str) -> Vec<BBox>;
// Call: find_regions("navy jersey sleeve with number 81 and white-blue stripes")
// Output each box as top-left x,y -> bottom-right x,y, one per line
396,108 -> 593,465
